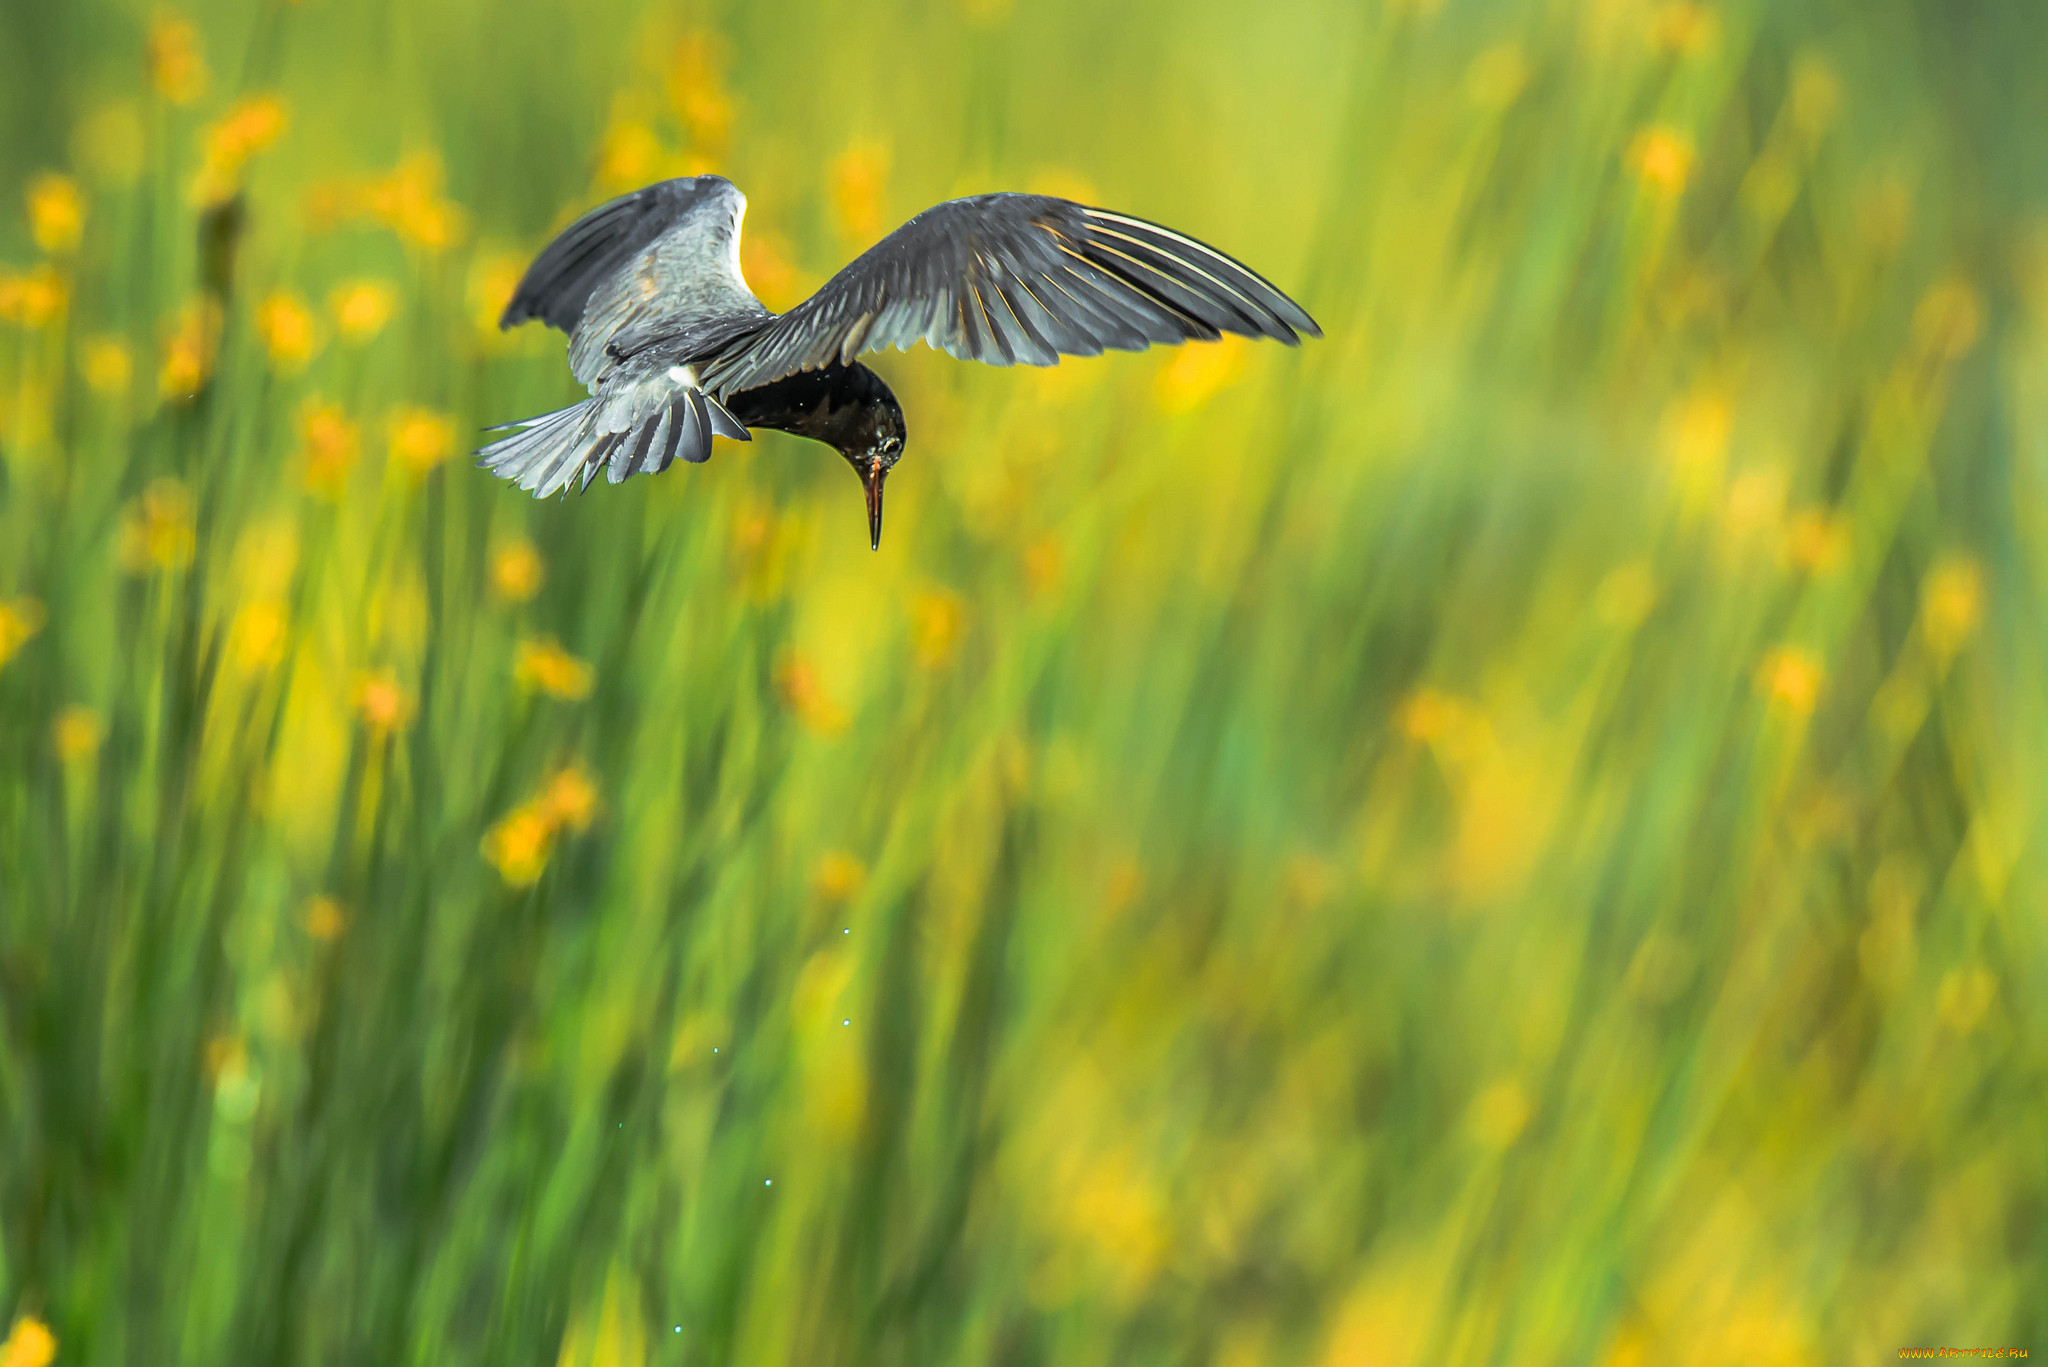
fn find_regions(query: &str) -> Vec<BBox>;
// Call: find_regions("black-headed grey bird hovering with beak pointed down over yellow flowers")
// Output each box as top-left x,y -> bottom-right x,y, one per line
477,176 -> 1323,549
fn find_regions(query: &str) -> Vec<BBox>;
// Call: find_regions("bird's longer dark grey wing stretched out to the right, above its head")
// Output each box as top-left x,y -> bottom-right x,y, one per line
705,195 -> 1323,396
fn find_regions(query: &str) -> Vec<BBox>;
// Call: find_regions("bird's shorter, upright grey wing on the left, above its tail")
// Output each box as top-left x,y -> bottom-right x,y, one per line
498,176 -> 768,385
